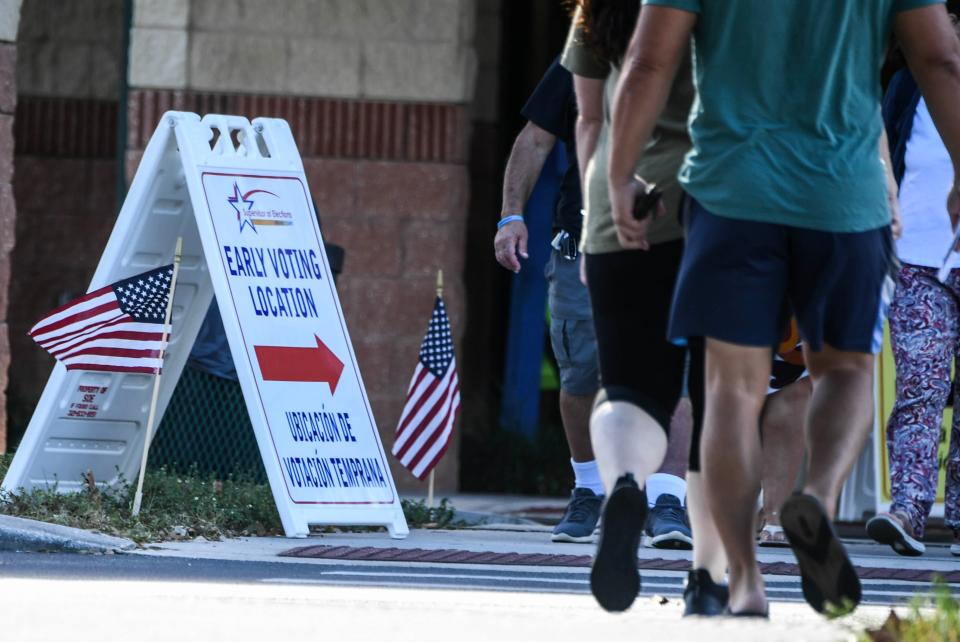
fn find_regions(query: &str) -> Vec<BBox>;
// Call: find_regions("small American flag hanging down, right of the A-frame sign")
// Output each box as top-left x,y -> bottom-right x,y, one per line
392,296 -> 460,479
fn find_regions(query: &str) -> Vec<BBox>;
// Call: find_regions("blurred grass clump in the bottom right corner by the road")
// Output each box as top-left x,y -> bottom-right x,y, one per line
859,581 -> 960,642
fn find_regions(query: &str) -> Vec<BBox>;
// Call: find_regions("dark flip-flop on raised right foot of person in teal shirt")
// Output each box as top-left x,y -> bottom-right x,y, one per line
780,493 -> 862,615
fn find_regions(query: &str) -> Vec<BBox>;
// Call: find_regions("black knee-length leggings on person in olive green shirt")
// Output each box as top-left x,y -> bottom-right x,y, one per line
585,240 -> 704,471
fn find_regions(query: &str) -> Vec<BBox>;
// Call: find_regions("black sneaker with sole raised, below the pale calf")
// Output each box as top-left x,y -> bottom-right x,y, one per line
590,473 -> 647,611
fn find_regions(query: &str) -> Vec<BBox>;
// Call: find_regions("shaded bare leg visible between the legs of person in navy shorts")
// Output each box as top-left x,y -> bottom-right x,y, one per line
760,378 -> 813,526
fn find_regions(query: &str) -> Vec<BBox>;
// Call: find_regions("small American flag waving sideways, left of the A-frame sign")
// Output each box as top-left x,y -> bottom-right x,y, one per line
28,265 -> 173,374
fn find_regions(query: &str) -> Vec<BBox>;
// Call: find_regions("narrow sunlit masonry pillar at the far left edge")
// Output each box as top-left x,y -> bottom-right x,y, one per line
0,0 -> 20,453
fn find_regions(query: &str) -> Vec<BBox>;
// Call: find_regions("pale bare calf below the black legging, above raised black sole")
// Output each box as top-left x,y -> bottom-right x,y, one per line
590,401 -> 667,494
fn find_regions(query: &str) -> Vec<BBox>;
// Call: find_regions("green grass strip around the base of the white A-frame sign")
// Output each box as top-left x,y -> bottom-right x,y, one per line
0,455 -> 455,544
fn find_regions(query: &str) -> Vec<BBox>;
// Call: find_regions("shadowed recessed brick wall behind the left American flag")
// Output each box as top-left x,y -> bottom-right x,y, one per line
7,0 -> 123,445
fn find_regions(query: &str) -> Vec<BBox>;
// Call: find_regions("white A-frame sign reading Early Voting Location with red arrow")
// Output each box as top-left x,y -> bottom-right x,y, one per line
3,112 -> 408,537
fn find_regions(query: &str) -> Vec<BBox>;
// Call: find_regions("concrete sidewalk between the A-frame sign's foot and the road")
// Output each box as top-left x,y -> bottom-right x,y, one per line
135,494 -> 960,580
